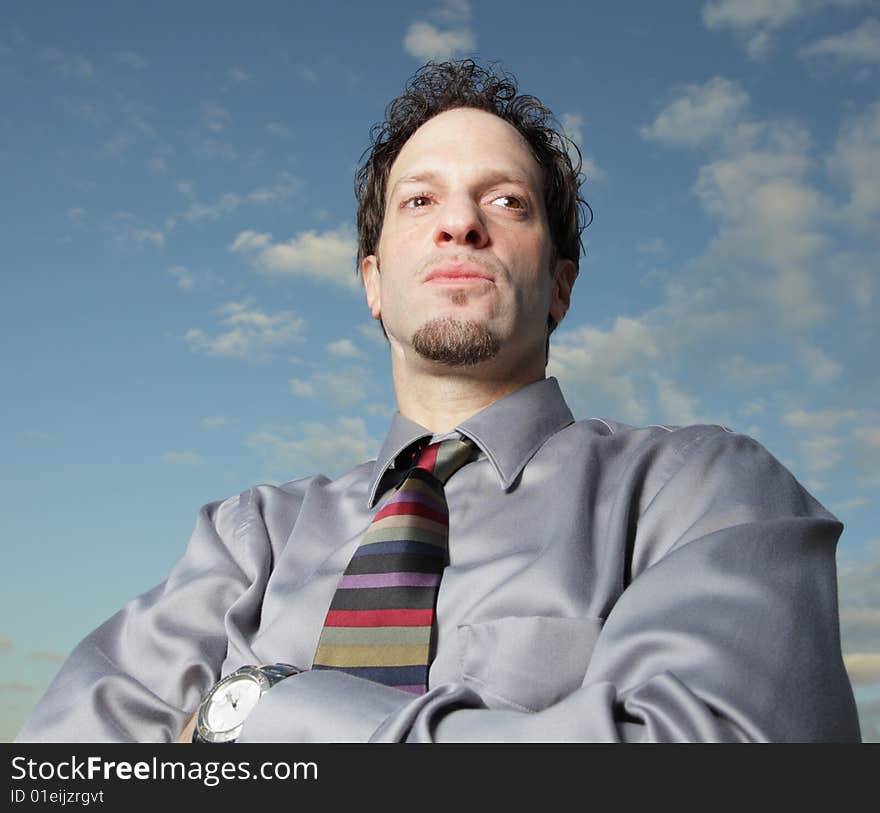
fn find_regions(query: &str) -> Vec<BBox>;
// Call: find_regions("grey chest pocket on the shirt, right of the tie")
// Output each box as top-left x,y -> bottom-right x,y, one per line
458,616 -> 603,711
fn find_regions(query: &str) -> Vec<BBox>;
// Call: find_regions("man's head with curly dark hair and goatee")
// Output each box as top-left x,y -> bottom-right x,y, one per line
356,60 -> 589,374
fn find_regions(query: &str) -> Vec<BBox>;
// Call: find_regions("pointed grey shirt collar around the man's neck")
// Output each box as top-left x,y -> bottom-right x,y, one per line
368,378 -> 574,507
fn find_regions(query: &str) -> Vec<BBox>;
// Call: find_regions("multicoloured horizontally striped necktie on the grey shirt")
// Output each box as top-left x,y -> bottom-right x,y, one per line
313,438 -> 474,694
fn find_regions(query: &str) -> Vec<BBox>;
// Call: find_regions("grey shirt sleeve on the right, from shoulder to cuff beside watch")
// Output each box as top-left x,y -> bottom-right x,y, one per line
241,429 -> 860,742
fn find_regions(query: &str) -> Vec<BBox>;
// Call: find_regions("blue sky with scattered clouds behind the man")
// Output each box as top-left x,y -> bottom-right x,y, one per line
0,0 -> 880,740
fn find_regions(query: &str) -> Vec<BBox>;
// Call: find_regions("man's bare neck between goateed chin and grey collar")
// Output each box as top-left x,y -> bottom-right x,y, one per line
392,354 -> 545,434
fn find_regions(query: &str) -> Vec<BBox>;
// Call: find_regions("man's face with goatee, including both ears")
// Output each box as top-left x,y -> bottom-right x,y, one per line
362,108 -> 574,371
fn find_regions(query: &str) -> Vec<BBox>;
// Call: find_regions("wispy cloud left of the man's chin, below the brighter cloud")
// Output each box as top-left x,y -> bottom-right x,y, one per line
183,301 -> 305,359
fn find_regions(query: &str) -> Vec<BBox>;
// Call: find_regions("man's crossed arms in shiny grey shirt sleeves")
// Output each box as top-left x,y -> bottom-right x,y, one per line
19,438 -> 859,742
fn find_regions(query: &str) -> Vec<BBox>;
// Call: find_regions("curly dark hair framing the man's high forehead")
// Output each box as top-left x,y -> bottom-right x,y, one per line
355,59 -> 592,322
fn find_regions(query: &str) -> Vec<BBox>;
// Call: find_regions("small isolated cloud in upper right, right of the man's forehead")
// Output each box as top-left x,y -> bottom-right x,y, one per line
640,76 -> 749,147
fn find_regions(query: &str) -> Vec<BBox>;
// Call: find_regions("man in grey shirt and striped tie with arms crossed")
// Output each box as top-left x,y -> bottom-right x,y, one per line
19,61 -> 859,742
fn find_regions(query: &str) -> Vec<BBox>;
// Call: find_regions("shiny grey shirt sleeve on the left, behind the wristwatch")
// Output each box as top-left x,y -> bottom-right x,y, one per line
16,497 -> 258,742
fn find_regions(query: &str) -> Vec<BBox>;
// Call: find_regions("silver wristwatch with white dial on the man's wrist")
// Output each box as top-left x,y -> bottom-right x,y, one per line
192,663 -> 300,743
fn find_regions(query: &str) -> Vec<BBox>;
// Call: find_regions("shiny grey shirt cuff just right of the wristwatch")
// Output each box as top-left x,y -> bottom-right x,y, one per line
236,669 -> 413,743
